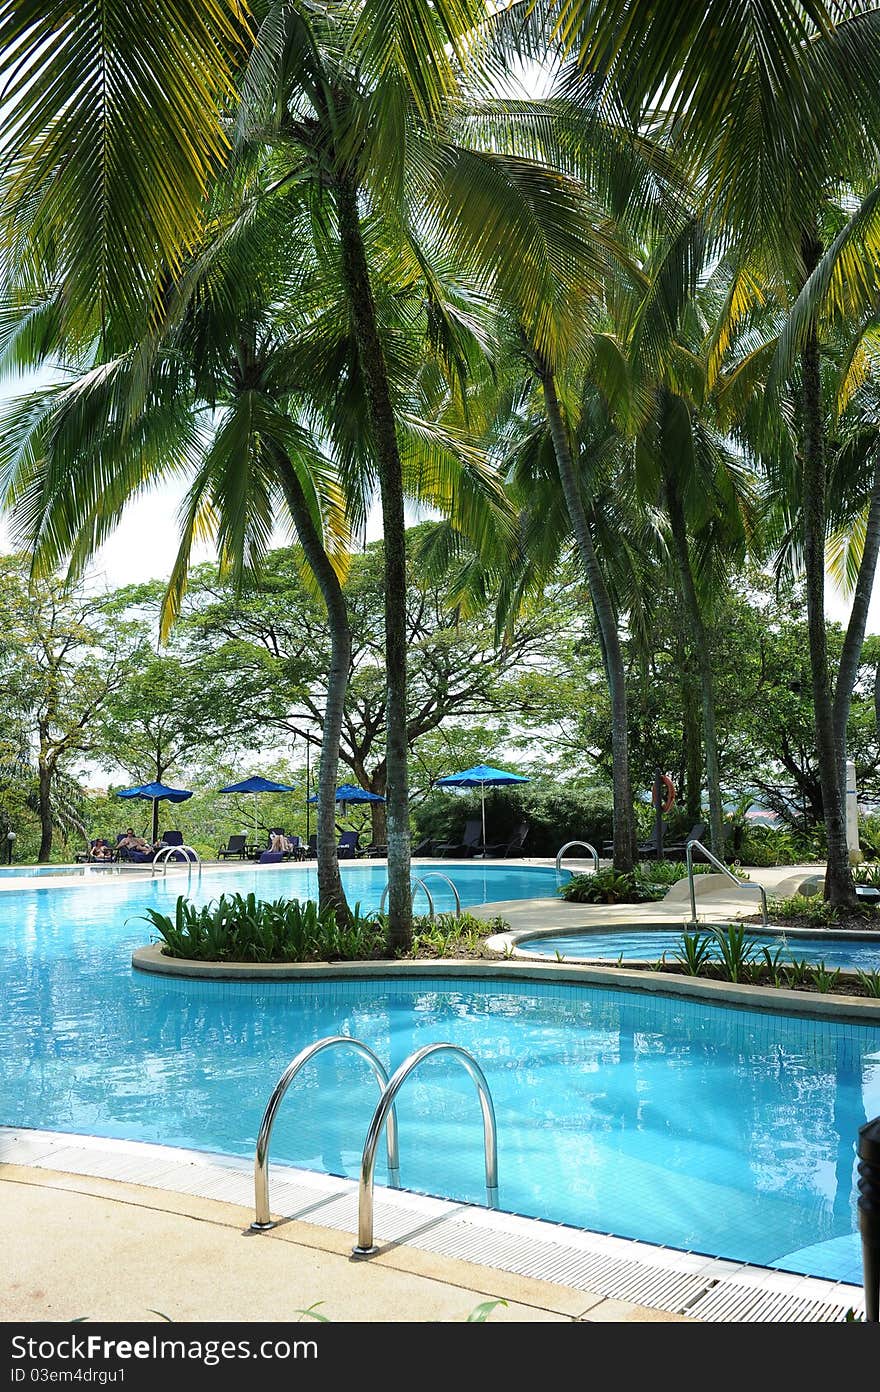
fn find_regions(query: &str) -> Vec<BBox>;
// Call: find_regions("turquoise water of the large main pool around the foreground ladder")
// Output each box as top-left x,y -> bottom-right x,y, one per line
0,866 -> 880,1279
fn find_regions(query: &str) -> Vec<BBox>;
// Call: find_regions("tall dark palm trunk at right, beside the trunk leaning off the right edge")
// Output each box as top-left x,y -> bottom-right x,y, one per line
801,232 -> 858,906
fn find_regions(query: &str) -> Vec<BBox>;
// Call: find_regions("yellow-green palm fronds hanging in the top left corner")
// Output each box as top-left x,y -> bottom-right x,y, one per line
0,0 -> 248,337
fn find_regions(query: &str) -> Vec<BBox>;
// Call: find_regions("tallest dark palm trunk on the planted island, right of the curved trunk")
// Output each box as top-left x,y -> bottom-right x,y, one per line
337,180 -> 412,951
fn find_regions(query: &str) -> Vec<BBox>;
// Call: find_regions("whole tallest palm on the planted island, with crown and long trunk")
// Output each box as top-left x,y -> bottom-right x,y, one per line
239,0 -> 615,945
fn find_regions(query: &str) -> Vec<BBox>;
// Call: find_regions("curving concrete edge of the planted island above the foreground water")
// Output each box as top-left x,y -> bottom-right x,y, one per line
131,944 -> 880,1025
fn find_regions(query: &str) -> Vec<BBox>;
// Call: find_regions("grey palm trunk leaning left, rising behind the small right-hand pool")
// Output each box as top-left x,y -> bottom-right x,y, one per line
539,366 -> 635,870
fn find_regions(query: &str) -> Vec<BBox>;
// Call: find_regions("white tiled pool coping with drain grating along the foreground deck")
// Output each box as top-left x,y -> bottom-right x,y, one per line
0,1126 -> 865,1322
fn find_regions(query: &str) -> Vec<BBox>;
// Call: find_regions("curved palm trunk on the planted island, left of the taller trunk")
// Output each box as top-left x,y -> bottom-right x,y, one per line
278,458 -> 351,927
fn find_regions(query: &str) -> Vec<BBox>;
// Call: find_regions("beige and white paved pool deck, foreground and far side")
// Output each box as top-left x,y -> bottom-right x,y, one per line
0,857 -> 863,1324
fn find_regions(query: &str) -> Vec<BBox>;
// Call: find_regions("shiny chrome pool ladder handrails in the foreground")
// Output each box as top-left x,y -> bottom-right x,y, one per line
251,1034 -> 498,1257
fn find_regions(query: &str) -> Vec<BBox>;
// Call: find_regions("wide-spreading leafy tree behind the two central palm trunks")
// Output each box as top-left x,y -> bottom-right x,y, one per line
184,526 -> 576,845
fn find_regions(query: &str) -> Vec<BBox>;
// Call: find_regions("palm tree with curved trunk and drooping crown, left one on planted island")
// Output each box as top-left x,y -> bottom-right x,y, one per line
0,193 -> 356,922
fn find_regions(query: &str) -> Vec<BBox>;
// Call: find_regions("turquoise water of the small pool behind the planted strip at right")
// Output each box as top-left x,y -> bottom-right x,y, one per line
517,928 -> 880,972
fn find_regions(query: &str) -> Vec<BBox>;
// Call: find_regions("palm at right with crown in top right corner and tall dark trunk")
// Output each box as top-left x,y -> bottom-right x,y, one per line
543,0 -> 880,903
